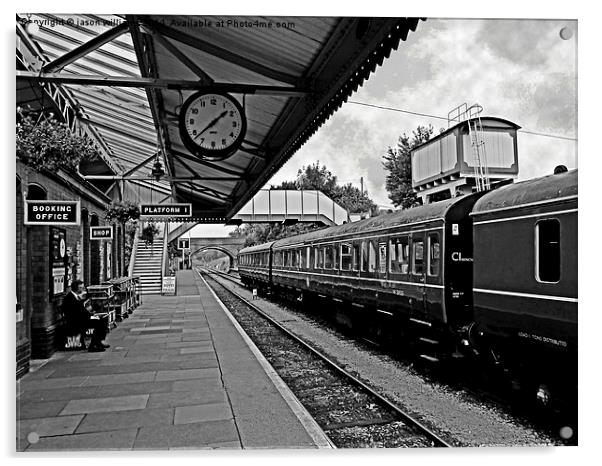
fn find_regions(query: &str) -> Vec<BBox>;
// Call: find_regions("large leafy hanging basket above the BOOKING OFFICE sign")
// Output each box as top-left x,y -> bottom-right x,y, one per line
16,108 -> 99,172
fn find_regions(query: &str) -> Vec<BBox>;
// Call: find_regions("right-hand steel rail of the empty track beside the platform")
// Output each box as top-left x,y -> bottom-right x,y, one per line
197,266 -> 453,448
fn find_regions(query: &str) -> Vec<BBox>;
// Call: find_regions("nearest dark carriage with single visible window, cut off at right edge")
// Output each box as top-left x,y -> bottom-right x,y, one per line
472,170 -> 577,376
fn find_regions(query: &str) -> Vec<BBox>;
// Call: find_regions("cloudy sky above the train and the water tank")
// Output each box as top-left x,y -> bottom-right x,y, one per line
193,18 -> 578,235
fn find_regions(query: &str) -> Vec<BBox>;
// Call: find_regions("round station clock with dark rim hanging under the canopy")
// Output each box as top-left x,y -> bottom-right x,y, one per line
180,93 -> 246,159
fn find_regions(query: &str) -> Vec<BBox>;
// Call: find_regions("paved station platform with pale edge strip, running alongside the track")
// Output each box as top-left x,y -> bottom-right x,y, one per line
16,270 -> 332,452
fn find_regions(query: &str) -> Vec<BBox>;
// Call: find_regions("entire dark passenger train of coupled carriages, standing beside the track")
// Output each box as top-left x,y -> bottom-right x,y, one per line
239,171 -> 577,402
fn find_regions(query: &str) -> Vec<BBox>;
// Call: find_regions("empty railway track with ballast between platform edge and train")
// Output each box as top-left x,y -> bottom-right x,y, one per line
199,270 -> 452,448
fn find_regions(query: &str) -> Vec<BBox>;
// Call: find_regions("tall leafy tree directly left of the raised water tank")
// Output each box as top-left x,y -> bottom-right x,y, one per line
383,125 -> 433,209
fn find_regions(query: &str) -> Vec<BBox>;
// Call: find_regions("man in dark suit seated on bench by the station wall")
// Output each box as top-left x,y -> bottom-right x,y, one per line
63,280 -> 109,352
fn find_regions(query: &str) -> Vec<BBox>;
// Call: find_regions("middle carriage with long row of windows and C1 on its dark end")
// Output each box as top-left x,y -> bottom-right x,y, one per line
258,191 -> 478,336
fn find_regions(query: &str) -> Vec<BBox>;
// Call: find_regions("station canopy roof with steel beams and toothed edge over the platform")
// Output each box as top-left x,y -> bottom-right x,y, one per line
17,14 -> 419,223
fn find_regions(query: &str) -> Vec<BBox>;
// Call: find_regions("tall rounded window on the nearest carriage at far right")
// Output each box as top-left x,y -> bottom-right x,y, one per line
535,219 -> 560,283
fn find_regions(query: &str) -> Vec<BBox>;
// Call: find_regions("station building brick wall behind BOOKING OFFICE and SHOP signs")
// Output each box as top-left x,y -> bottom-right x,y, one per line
15,161 -> 127,377
